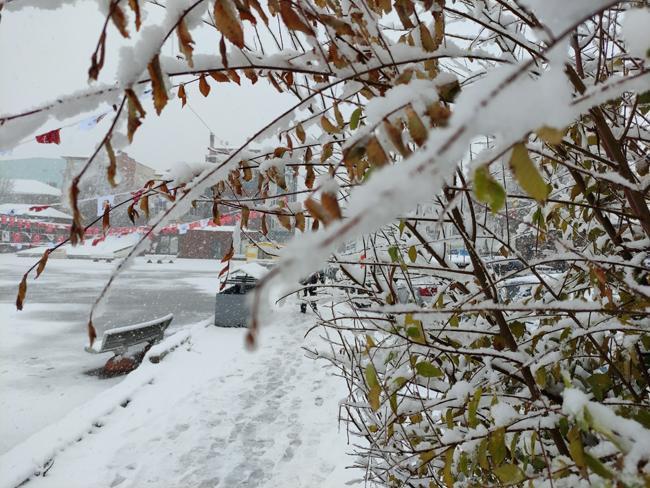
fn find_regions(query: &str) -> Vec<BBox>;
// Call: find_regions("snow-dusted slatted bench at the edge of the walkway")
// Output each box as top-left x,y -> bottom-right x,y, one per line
86,313 -> 174,374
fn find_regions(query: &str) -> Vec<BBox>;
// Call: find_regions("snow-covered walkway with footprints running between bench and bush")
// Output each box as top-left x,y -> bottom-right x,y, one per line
0,306 -> 359,488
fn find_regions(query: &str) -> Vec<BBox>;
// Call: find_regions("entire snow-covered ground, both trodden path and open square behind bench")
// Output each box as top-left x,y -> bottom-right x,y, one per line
0,256 -> 359,488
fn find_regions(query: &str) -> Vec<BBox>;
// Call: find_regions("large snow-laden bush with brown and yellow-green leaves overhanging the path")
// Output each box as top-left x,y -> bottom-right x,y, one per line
0,0 -> 650,487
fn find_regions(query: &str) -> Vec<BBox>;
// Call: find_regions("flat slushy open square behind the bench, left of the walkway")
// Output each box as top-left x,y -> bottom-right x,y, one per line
0,254 -> 235,454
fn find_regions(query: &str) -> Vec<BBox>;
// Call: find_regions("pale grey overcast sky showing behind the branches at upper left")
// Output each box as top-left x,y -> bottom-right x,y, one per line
0,0 -> 293,169
